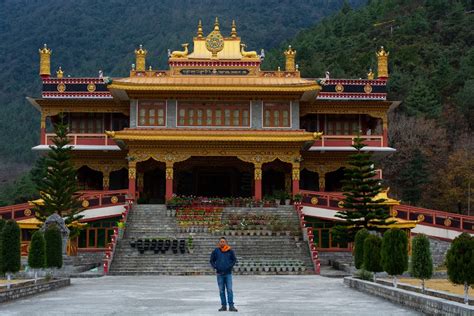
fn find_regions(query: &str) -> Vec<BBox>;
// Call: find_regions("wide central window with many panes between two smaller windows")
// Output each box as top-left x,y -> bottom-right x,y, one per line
177,102 -> 250,127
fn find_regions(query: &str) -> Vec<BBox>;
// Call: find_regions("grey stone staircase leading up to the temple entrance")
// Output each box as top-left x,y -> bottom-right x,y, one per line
109,205 -> 313,275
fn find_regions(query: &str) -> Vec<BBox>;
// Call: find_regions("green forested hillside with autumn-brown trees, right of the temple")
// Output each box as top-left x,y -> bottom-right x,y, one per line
266,0 -> 474,213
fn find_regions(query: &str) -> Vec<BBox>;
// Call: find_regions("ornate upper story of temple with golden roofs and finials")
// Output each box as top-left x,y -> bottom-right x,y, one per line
28,18 -> 394,151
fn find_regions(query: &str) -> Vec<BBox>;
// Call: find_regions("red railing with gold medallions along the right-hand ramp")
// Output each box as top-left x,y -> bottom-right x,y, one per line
301,190 -> 474,234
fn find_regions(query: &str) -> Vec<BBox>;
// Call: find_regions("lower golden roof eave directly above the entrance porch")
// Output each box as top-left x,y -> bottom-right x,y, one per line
106,128 -> 316,142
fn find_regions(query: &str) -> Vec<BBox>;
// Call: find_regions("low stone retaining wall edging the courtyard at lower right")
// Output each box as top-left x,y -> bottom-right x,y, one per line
344,277 -> 474,316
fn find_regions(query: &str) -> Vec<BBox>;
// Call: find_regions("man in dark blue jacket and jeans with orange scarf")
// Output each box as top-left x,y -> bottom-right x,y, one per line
210,237 -> 237,312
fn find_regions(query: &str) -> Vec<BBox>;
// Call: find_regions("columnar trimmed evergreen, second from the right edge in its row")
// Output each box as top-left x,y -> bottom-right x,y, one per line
411,235 -> 433,293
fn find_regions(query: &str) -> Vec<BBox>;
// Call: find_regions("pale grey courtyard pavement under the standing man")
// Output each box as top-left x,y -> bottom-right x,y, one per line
0,276 -> 418,316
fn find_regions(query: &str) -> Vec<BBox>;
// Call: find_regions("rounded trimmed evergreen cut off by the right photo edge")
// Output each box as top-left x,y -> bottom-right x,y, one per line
446,233 -> 474,304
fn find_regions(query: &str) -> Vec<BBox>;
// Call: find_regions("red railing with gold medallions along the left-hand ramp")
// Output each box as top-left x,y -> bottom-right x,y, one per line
0,189 -> 128,220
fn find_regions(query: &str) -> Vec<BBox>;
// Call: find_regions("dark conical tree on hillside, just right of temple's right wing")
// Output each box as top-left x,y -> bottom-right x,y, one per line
400,149 -> 429,205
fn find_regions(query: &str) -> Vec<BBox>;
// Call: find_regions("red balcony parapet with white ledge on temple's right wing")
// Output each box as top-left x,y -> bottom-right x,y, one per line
310,135 -> 395,152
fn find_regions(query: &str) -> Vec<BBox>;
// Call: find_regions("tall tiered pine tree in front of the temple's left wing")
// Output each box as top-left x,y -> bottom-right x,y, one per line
33,117 -> 82,236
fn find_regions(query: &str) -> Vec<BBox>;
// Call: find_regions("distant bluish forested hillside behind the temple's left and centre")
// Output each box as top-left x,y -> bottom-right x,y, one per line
0,0 -> 365,163
